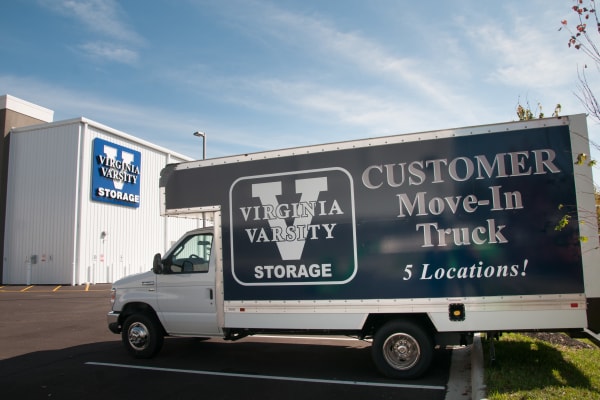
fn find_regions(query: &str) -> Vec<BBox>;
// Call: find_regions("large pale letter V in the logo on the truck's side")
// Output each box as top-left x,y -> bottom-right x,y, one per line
252,177 -> 327,260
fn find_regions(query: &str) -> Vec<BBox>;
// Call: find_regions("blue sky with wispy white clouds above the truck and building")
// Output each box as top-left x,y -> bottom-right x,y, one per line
0,0 -> 600,170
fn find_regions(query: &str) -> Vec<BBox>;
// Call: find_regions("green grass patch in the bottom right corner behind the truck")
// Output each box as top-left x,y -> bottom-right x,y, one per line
483,334 -> 600,400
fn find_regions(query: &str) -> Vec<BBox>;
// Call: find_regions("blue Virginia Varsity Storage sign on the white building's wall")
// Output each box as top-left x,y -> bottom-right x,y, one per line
92,138 -> 142,208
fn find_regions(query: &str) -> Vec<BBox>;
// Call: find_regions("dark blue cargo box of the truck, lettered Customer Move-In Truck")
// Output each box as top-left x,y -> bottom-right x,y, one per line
160,116 -> 597,330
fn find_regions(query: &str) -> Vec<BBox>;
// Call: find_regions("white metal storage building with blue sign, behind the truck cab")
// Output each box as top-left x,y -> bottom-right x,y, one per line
2,99 -> 200,285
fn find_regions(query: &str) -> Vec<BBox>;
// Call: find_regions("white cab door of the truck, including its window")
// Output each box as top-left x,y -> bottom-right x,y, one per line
156,231 -> 219,336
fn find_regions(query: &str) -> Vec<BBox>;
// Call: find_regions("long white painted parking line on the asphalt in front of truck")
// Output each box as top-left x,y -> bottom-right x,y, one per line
85,361 -> 446,390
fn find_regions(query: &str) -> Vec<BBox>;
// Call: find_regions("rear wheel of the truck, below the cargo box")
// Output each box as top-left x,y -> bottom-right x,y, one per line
372,320 -> 434,379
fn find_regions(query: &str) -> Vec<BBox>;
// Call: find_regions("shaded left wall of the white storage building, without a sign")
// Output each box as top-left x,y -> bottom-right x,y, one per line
3,124 -> 79,284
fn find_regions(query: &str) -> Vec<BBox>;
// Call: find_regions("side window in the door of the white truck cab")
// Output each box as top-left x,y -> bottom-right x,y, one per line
166,233 -> 213,273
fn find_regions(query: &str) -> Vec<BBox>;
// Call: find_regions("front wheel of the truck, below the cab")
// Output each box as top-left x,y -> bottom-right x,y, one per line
121,314 -> 164,358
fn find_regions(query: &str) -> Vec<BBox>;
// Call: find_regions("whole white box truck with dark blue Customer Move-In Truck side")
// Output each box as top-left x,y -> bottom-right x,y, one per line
108,115 -> 600,378
